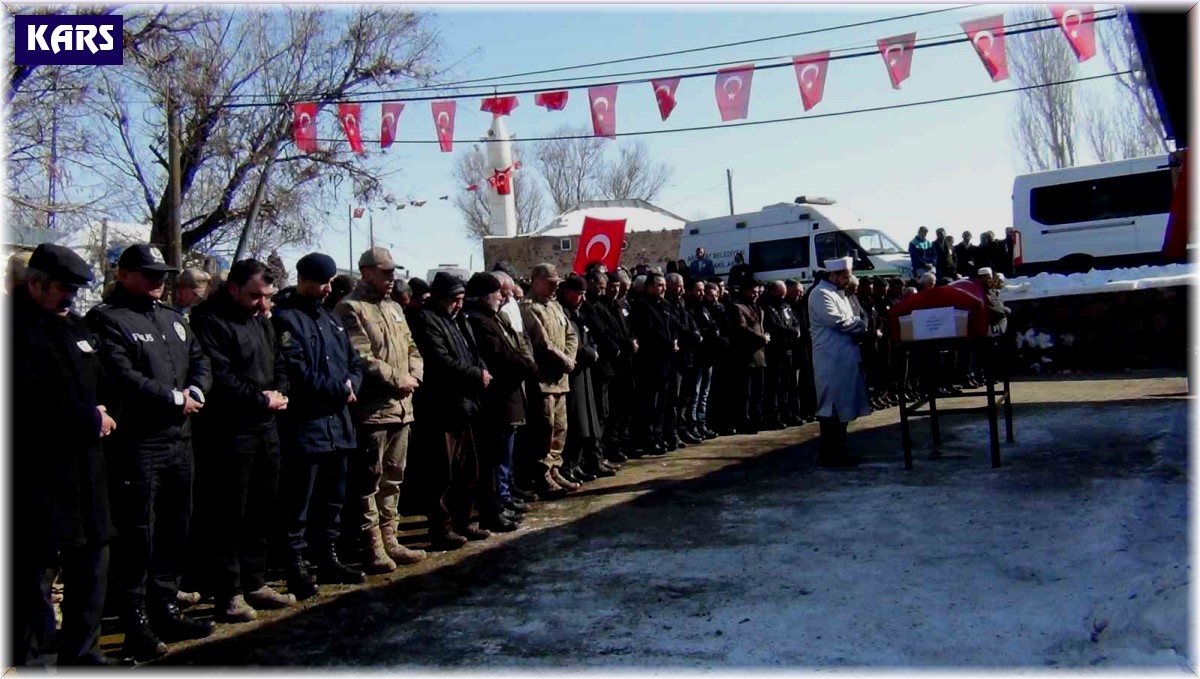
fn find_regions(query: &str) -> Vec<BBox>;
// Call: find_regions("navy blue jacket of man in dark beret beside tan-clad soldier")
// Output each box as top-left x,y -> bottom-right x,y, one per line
271,288 -> 362,455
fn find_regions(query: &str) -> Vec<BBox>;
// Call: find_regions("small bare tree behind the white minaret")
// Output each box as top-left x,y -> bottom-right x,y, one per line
454,144 -> 546,240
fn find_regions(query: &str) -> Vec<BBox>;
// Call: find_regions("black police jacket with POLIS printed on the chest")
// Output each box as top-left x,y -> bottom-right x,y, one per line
86,283 -> 212,450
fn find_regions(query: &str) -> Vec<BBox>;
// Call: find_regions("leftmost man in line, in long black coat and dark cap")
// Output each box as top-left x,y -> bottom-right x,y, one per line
8,244 -> 116,666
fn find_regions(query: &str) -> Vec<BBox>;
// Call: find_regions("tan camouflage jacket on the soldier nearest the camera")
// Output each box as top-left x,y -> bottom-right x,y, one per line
334,281 -> 425,425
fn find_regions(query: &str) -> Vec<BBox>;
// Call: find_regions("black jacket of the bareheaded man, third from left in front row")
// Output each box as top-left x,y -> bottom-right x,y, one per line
188,288 -> 288,433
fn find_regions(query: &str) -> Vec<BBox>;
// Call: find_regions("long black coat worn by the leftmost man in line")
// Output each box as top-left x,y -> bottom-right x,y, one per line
10,288 -> 120,559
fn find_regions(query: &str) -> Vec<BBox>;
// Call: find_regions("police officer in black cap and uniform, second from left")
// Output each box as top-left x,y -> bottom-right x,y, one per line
88,245 -> 212,659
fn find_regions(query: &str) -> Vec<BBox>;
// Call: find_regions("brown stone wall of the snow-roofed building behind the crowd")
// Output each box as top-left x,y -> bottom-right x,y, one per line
484,229 -> 683,276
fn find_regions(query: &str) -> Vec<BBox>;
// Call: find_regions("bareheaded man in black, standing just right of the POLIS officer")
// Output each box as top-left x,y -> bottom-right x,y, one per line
191,259 -> 296,623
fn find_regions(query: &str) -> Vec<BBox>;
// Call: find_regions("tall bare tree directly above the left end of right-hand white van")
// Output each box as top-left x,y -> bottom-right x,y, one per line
1008,5 -> 1078,172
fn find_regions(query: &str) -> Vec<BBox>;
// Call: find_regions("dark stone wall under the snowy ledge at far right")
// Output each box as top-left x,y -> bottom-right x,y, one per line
1007,286 -> 1193,373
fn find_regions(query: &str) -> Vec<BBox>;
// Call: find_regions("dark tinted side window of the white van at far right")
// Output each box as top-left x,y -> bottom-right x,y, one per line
1030,169 -> 1175,226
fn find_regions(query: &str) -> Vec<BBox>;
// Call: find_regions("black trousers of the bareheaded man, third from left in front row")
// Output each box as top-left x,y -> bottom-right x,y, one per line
206,423 -> 280,601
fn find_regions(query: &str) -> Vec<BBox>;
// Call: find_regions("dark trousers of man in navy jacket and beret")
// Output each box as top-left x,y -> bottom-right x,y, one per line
277,450 -> 350,559
